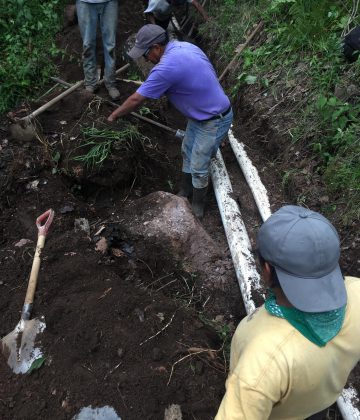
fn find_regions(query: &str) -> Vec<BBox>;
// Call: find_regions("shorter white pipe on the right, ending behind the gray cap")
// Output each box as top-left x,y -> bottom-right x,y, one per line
229,130 -> 271,222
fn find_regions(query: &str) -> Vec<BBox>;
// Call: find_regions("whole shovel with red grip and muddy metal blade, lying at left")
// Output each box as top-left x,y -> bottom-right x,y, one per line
1,209 -> 54,374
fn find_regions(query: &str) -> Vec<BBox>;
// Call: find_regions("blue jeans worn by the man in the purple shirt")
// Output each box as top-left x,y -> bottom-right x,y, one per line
181,110 -> 233,188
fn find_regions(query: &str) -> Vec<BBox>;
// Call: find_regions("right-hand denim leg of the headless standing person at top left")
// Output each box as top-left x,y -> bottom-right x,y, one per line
100,0 -> 118,99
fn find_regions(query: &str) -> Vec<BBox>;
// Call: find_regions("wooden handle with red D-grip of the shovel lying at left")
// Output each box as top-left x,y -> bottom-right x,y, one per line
21,209 -> 55,320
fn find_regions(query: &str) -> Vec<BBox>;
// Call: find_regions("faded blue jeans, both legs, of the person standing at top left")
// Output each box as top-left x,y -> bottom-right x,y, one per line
76,0 -> 118,89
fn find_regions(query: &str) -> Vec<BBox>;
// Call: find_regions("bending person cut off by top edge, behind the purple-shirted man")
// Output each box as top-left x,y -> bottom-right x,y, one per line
144,0 -> 209,29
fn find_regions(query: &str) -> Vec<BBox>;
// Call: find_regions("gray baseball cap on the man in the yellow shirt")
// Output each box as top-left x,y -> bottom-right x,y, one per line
257,206 -> 347,312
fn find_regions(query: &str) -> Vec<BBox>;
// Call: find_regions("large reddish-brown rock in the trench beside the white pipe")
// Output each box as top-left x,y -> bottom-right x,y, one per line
125,191 -> 221,271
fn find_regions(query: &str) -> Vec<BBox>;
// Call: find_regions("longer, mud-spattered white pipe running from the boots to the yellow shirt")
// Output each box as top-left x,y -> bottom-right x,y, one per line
210,151 -> 263,314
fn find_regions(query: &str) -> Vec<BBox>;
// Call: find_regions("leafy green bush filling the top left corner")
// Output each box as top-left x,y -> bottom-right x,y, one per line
0,0 -> 64,112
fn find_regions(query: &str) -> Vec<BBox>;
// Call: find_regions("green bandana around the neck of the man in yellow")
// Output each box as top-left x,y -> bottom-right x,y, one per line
265,289 -> 346,347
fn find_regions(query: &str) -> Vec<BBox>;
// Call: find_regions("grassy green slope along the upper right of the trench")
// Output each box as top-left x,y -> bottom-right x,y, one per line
204,0 -> 360,223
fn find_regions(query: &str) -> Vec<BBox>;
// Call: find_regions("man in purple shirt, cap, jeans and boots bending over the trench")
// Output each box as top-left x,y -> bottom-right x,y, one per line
108,24 -> 233,219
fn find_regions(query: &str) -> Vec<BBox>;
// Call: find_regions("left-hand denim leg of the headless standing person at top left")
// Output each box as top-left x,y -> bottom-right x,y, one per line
76,0 -> 98,89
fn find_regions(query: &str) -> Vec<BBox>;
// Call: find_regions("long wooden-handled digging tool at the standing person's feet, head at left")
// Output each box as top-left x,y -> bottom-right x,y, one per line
10,64 -> 130,141
